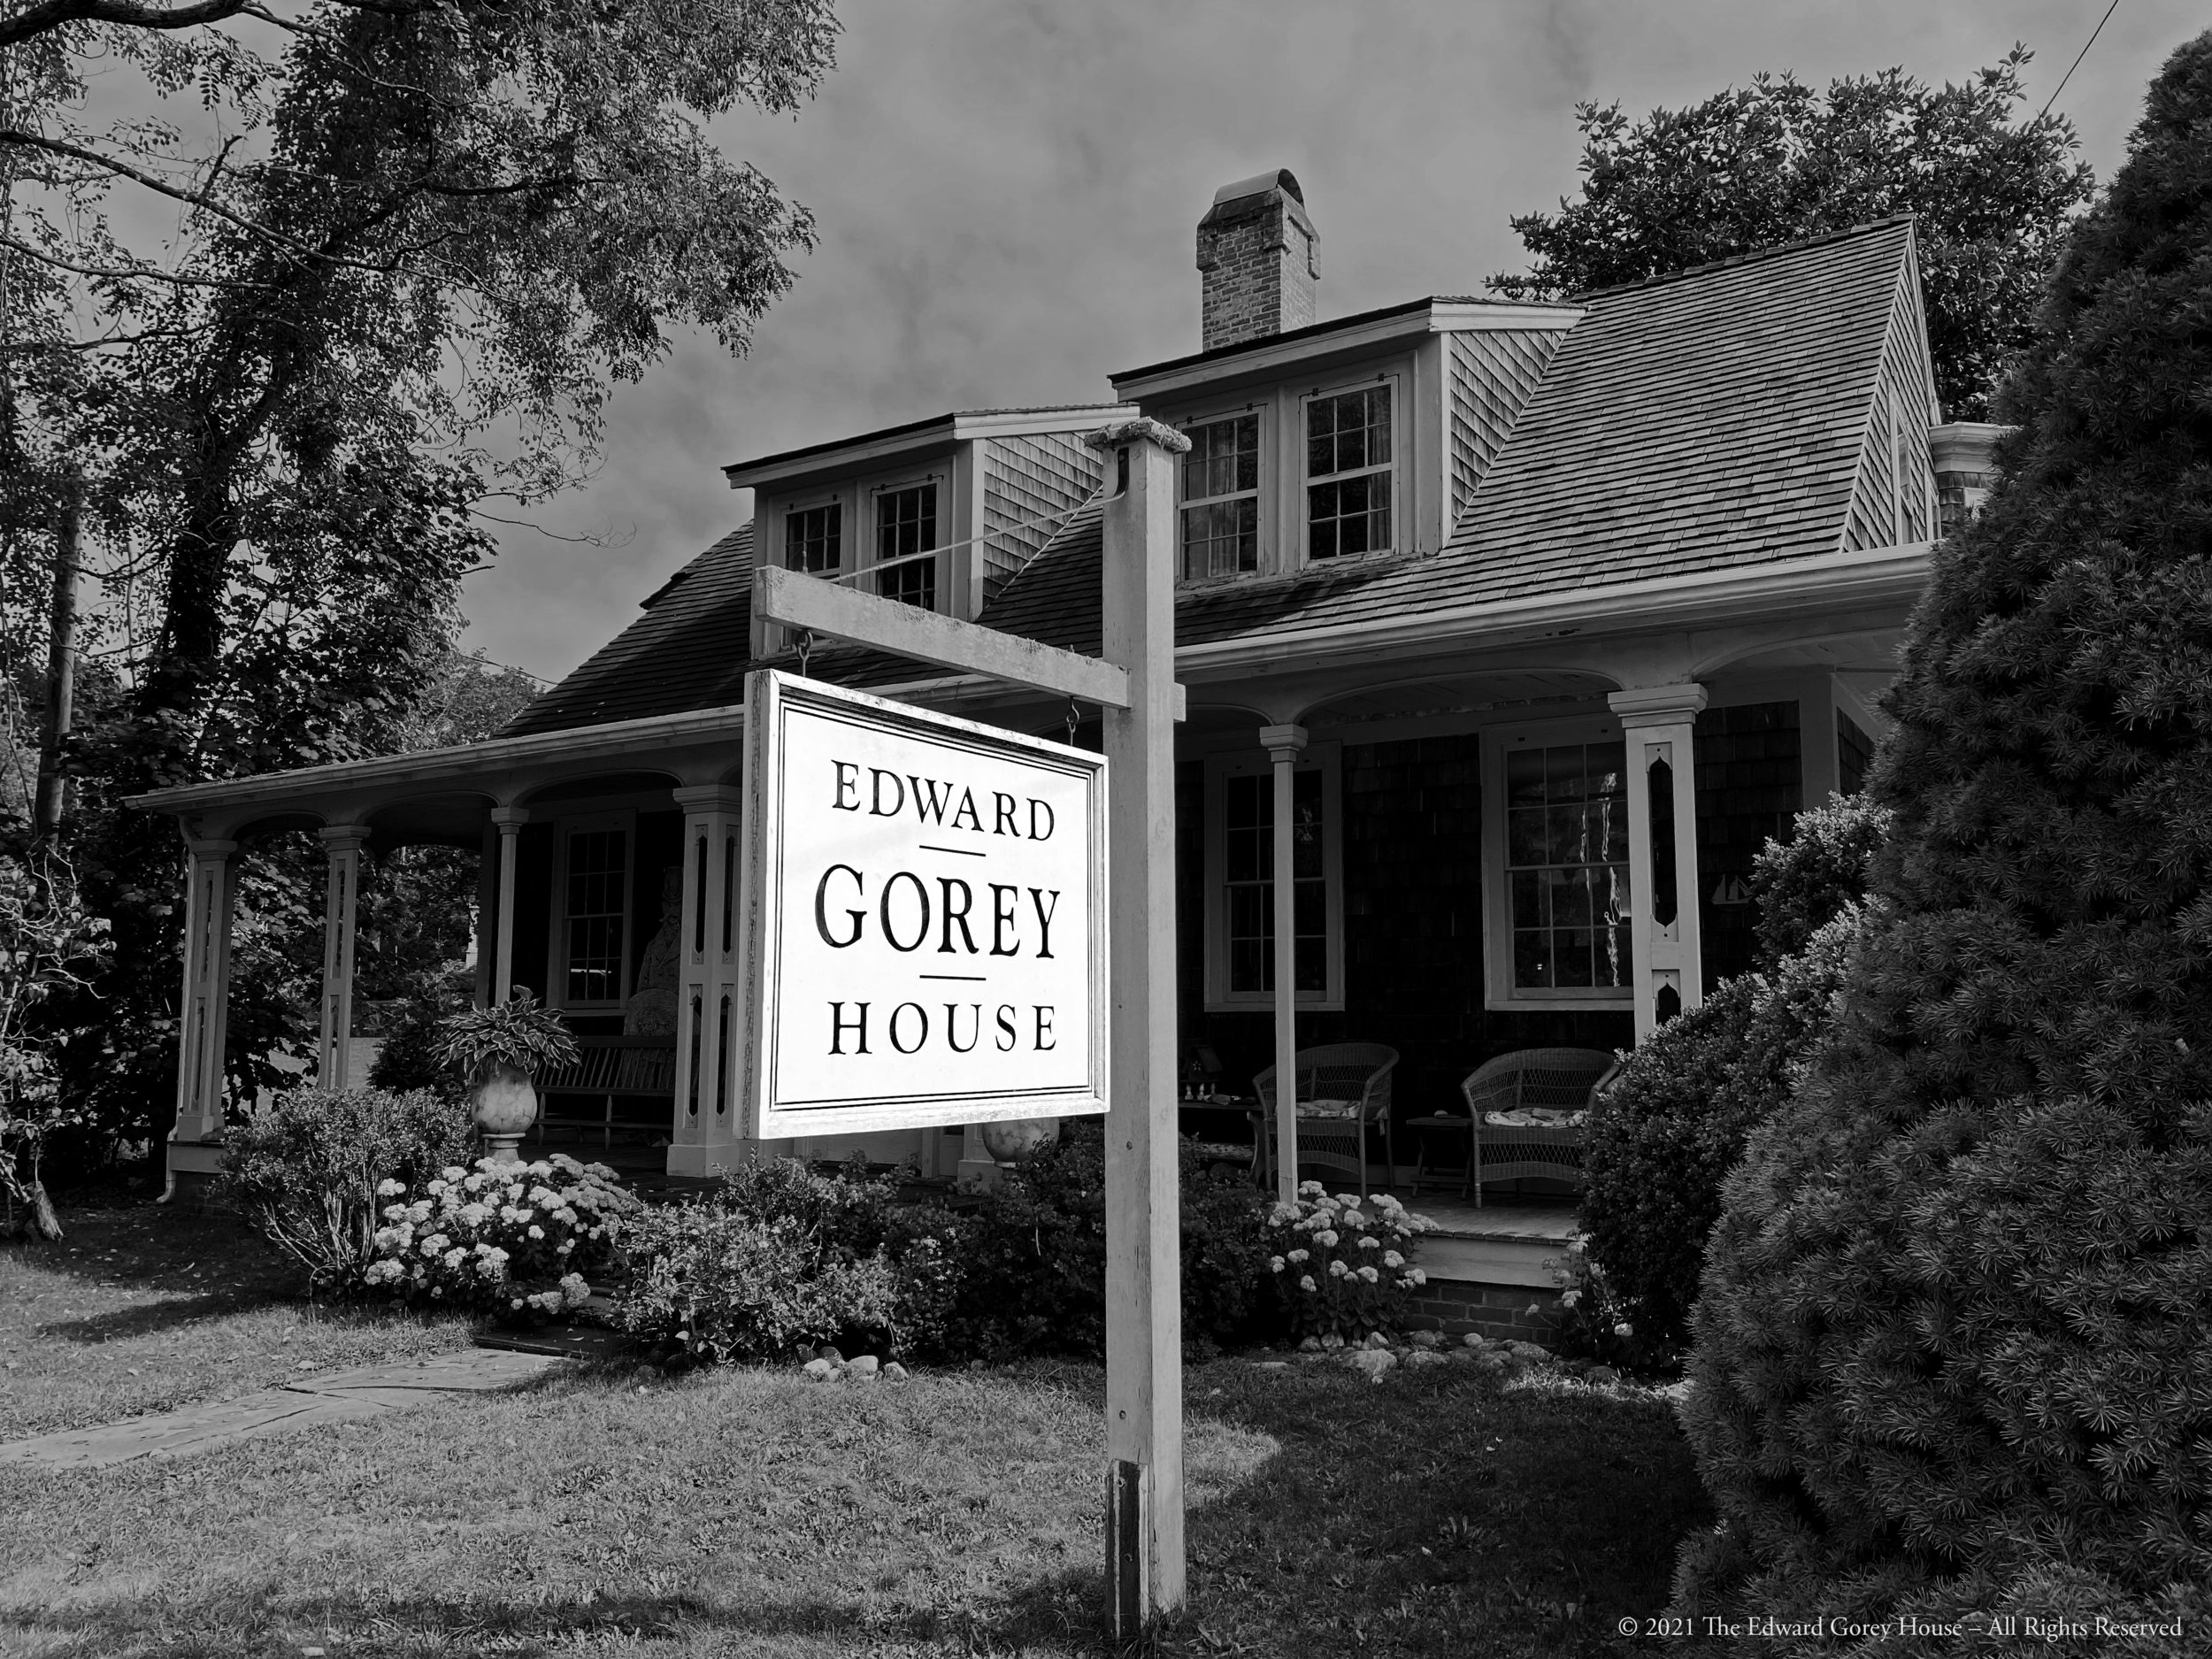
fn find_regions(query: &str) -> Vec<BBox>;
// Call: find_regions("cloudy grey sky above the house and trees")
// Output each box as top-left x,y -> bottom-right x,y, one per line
463,0 -> 2203,680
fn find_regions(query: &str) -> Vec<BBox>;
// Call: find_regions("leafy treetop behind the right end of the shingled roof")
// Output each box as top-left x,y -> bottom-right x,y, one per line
1489,47 -> 2091,420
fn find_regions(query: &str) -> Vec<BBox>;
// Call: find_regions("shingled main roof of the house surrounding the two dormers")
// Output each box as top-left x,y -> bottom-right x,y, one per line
507,219 -> 1911,734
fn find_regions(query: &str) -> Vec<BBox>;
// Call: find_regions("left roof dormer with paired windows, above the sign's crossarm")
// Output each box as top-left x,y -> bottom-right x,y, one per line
724,405 -> 1133,657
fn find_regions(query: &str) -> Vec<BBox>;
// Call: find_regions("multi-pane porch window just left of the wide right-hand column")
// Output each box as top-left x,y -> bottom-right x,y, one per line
1504,743 -> 1631,991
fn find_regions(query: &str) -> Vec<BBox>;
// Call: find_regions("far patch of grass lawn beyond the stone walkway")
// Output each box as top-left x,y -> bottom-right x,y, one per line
0,1203 -> 469,1440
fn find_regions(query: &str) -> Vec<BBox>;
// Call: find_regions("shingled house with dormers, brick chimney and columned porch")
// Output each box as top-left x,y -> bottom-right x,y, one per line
140,173 -> 1995,1248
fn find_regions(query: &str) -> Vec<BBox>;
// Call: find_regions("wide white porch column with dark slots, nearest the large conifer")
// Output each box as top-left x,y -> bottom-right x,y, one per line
1606,684 -> 1706,1042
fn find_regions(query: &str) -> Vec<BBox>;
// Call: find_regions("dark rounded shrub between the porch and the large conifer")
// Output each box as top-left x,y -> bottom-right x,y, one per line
1582,796 -> 1889,1365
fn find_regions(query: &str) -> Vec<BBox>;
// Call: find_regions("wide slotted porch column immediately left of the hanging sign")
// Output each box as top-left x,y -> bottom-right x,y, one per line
668,783 -> 746,1175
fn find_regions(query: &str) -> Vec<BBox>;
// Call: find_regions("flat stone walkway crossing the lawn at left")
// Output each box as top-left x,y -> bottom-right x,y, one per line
0,1348 -> 569,1469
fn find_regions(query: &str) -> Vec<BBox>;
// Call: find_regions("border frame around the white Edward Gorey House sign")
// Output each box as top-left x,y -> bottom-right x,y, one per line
739,668 -> 1113,1141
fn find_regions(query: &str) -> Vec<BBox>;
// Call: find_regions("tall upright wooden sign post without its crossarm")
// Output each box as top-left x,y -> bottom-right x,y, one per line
1087,420 -> 1190,1640
